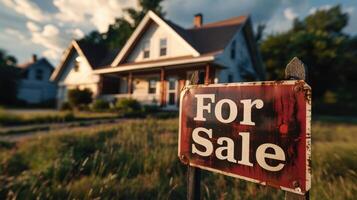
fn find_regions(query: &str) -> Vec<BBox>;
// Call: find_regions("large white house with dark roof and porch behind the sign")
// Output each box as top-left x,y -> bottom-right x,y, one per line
51,11 -> 264,109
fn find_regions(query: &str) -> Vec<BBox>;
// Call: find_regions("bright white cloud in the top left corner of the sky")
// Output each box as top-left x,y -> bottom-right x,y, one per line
1,0 -> 49,22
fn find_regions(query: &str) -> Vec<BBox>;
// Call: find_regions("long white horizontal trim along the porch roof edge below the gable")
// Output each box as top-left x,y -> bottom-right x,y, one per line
93,56 -> 214,74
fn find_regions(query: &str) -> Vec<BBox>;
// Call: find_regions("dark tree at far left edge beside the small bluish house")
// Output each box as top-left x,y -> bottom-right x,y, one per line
0,49 -> 19,105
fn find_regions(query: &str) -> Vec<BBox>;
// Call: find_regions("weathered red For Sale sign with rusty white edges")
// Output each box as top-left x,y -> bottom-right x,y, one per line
178,81 -> 311,194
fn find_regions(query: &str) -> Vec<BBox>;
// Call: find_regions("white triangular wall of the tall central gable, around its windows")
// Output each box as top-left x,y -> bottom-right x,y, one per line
122,22 -> 193,63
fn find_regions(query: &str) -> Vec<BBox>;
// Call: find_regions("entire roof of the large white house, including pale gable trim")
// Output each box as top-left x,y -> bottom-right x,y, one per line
52,11 -> 264,79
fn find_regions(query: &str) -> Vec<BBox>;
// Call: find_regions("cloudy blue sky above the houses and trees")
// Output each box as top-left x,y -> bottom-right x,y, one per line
0,0 -> 357,66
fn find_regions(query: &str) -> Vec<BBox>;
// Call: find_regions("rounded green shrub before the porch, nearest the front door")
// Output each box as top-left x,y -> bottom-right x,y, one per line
115,98 -> 143,117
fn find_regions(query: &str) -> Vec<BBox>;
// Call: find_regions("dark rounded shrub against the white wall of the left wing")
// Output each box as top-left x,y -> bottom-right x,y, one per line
68,88 -> 93,108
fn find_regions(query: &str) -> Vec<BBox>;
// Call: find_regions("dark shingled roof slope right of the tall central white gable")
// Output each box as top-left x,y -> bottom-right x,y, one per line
165,16 -> 247,54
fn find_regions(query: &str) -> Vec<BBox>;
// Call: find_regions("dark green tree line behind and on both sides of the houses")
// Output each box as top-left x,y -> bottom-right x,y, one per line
0,0 -> 357,114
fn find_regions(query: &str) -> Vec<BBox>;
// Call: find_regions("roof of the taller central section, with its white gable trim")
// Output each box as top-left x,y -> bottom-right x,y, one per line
112,11 -> 248,66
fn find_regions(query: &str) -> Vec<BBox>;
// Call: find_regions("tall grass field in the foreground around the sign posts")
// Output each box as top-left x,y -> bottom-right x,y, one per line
0,119 -> 357,200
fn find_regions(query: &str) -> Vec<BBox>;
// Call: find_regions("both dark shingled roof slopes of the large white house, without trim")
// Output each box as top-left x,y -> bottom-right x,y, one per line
77,16 -> 247,69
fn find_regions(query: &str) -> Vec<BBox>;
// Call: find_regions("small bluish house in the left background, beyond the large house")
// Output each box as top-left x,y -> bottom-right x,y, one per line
17,55 -> 57,104
